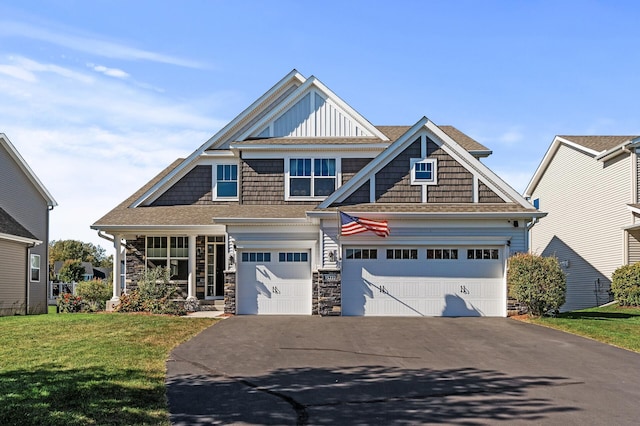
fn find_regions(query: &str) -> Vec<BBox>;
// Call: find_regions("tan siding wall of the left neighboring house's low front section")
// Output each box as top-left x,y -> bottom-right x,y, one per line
0,239 -> 27,316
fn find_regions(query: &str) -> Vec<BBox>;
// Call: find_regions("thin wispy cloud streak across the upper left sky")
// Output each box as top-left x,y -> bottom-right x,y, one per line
0,21 -> 205,68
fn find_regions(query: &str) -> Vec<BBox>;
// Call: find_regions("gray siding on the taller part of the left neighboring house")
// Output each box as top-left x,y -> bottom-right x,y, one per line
0,141 -> 49,314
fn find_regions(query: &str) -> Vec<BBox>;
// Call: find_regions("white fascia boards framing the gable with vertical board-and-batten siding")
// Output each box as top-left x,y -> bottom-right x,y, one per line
238,76 -> 389,141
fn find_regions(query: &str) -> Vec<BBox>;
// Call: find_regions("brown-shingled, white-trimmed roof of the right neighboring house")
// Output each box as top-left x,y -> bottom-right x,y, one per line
524,136 -> 640,197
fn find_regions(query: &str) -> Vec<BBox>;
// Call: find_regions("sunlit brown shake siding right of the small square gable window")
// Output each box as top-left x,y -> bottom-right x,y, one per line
427,141 -> 473,203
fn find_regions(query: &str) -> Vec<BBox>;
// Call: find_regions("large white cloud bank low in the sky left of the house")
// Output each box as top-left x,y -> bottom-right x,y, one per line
0,57 -> 226,250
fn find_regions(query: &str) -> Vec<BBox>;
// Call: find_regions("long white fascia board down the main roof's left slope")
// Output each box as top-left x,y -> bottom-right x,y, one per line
130,69 -> 305,207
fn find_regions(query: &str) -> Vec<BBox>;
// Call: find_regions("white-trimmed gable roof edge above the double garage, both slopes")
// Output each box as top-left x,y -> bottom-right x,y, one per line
318,117 -> 533,209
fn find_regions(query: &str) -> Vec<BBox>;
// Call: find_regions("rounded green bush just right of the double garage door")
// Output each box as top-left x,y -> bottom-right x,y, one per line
507,253 -> 567,316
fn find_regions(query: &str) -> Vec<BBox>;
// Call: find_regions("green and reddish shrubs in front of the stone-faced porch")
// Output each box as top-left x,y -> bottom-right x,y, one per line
116,267 -> 186,315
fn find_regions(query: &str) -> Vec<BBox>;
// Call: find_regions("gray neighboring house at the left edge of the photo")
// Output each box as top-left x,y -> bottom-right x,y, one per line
0,133 -> 58,315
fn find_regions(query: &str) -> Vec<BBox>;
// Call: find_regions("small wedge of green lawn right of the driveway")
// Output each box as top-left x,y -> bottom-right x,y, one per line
526,305 -> 640,352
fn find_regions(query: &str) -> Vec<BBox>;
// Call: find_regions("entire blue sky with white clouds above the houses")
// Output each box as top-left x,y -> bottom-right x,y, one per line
0,0 -> 640,248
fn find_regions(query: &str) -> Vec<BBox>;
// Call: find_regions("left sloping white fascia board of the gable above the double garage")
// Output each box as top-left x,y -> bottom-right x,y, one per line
318,117 -> 429,209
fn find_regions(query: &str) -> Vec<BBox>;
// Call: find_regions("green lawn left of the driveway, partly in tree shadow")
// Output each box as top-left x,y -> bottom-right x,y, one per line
0,308 -> 216,426
